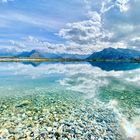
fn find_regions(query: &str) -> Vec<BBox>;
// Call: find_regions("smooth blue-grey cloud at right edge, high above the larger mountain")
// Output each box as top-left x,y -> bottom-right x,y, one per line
101,0 -> 140,44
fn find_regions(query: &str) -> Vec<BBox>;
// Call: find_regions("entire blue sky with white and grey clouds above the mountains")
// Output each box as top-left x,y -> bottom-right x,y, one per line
0,0 -> 140,55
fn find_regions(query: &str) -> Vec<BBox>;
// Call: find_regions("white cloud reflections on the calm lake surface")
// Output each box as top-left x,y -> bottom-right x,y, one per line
0,63 -> 140,137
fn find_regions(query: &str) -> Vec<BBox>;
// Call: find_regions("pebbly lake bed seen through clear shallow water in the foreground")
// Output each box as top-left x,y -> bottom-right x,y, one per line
0,94 -> 124,140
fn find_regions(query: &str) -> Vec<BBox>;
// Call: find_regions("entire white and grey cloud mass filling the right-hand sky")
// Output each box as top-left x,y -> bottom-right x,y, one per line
59,0 -> 140,53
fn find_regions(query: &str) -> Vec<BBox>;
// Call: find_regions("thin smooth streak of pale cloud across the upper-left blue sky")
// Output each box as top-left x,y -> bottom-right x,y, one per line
0,10 -> 64,31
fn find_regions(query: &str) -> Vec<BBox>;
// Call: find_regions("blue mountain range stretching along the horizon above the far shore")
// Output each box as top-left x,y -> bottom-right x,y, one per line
0,48 -> 140,60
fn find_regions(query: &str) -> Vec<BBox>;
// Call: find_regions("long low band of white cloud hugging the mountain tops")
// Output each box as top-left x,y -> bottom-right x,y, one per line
3,36 -> 127,55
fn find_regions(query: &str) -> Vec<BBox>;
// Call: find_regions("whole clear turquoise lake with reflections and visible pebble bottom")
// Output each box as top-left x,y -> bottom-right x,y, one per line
0,62 -> 140,140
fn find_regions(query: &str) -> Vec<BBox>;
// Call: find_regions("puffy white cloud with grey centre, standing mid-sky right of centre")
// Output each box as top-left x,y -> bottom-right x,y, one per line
59,12 -> 108,45
